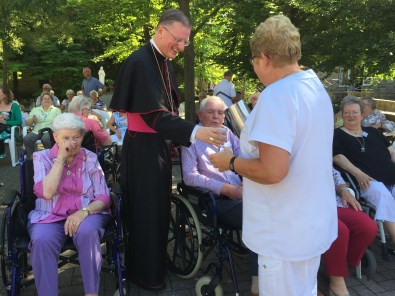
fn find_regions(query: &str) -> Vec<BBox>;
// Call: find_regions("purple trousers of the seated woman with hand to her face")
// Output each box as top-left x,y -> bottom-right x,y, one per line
28,214 -> 110,296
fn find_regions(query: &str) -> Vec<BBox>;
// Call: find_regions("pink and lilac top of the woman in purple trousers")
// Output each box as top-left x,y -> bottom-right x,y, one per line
29,144 -> 110,223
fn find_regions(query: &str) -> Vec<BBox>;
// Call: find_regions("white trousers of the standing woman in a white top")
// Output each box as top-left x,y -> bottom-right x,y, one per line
258,255 -> 321,296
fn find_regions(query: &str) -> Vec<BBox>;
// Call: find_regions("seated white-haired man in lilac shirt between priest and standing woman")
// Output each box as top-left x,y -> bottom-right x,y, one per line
181,96 -> 258,295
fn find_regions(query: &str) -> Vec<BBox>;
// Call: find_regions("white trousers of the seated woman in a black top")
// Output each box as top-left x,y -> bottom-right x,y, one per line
361,181 -> 395,222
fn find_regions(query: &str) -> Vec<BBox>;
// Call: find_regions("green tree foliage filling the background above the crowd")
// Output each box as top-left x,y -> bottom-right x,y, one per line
0,0 -> 395,102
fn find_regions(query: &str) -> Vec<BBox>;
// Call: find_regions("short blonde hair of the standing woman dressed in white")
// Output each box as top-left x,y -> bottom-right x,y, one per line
250,15 -> 302,67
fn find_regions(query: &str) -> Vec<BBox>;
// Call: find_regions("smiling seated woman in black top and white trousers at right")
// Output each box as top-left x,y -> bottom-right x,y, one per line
333,96 -> 395,242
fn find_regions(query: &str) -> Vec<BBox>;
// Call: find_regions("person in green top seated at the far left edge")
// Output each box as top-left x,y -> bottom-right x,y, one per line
0,86 -> 22,159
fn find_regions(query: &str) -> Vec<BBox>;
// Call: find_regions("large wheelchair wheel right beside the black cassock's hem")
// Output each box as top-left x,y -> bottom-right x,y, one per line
167,195 -> 203,279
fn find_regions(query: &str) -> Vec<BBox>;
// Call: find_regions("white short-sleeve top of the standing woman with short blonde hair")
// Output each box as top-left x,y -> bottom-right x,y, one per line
240,70 -> 337,261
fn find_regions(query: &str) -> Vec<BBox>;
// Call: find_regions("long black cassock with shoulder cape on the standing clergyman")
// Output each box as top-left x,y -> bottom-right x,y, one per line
110,43 -> 195,287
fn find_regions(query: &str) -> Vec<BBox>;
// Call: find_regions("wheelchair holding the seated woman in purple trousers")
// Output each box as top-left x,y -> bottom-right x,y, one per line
0,152 -> 127,296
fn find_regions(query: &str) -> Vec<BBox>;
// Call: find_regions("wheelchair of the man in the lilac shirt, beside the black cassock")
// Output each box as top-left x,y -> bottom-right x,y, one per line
167,183 -> 248,296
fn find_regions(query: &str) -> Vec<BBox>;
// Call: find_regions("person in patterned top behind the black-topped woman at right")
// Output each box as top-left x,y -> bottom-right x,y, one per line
362,97 -> 395,132
